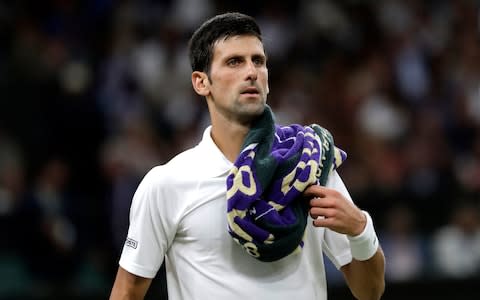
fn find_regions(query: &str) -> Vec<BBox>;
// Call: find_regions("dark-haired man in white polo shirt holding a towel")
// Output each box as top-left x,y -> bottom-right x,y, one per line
110,13 -> 385,300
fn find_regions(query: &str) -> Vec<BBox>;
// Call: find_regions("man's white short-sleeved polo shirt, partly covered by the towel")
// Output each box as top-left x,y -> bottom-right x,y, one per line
120,127 -> 352,300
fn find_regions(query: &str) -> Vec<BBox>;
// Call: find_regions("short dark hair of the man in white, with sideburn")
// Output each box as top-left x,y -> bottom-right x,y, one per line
188,12 -> 262,74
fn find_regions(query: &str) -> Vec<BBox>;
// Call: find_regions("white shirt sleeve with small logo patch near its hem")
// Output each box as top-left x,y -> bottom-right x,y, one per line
119,167 -> 175,278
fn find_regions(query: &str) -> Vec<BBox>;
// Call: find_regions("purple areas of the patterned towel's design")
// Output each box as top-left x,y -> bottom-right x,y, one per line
227,124 -> 322,243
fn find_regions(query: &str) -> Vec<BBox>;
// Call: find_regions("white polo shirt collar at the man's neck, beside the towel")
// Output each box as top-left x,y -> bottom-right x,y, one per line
198,126 -> 233,177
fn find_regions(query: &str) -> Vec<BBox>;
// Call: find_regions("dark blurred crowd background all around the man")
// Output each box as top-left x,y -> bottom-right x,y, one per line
0,0 -> 480,299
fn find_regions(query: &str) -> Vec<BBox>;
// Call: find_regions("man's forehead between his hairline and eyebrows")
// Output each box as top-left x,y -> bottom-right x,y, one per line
213,35 -> 265,60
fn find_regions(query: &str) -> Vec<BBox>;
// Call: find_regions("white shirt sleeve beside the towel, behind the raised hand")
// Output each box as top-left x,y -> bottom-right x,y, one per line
323,171 -> 353,269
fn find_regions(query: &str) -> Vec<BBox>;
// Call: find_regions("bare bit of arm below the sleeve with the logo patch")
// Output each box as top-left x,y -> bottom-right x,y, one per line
110,267 -> 152,300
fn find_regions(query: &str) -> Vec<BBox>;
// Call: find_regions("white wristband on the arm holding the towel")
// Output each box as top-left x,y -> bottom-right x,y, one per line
347,210 -> 378,260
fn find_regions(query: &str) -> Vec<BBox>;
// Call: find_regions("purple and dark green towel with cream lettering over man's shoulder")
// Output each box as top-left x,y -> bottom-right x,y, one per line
226,106 -> 346,262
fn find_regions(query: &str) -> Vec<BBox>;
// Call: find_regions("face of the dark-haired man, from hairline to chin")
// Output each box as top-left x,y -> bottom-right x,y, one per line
207,35 -> 268,123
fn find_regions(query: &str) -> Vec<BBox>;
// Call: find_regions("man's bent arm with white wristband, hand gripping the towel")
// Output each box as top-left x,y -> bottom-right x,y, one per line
304,185 -> 385,300
